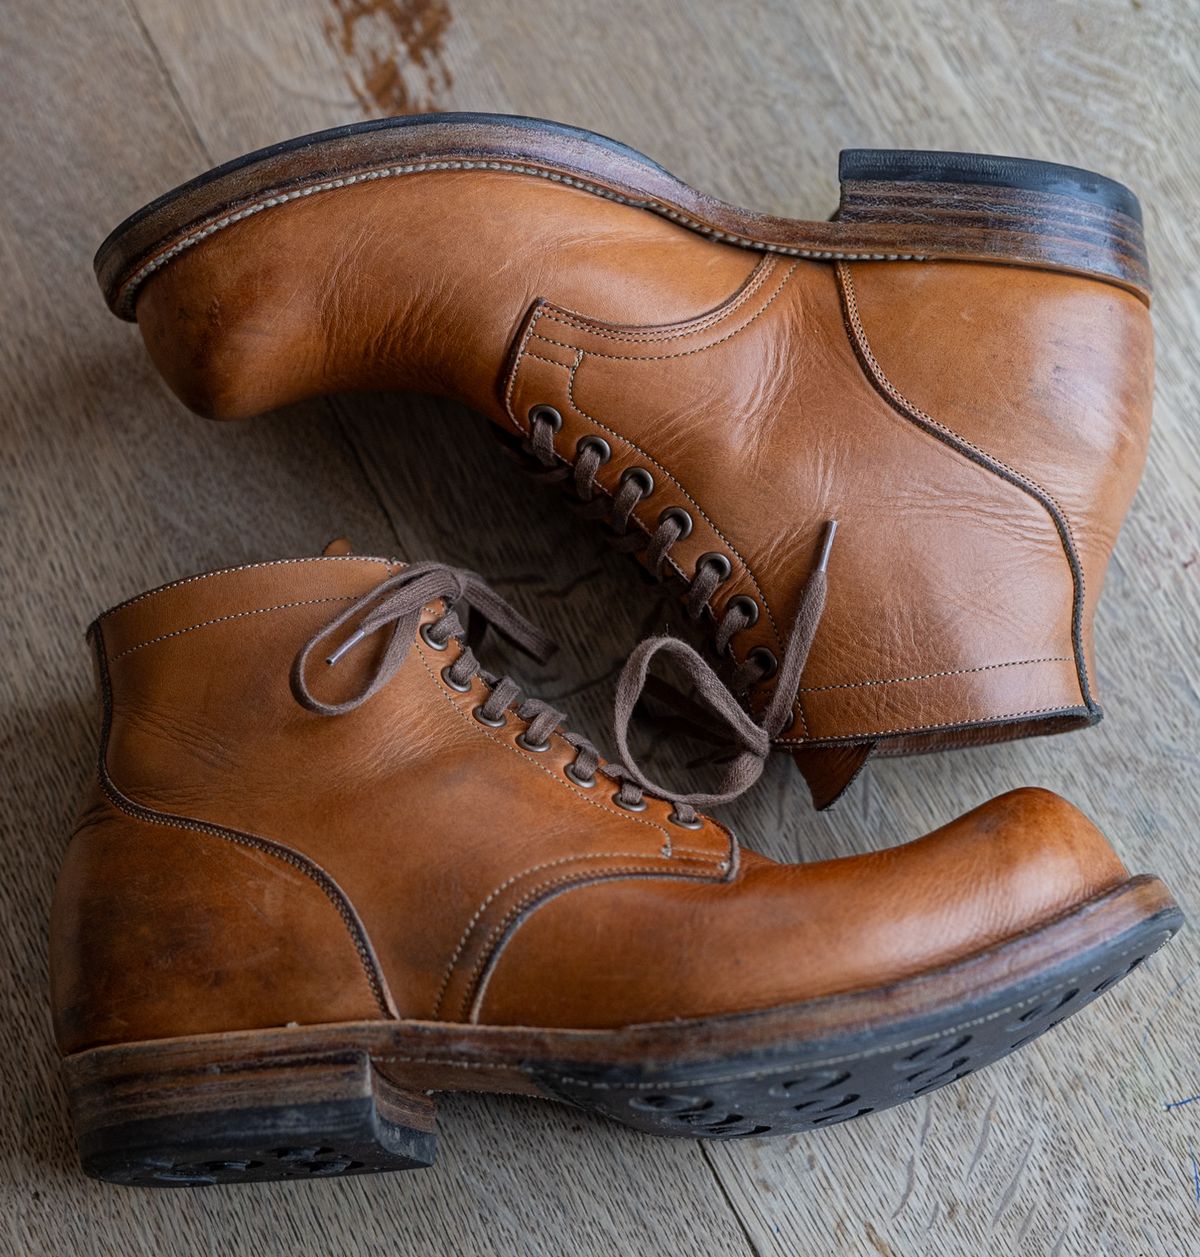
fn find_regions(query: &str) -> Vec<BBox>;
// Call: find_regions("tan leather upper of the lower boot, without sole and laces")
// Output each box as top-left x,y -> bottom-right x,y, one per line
52,557 -> 1125,1052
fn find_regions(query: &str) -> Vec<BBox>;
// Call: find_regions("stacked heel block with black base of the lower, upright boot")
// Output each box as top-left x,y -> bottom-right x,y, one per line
64,1041 -> 436,1187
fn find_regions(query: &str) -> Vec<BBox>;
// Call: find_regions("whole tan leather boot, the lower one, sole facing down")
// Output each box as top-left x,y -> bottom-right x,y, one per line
52,557 -> 1180,1185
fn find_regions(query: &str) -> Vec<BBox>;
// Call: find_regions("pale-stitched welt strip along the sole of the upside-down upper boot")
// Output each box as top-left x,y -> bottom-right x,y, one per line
113,160 -> 925,317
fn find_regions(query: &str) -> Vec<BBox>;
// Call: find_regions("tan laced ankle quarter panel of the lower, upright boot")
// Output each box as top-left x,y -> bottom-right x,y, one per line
89,559 -> 735,1018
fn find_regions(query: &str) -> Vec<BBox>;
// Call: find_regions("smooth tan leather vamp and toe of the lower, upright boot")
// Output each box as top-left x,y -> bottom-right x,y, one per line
470,789 -> 1125,1026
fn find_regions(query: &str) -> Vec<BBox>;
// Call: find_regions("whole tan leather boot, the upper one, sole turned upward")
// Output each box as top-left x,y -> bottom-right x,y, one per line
97,114 -> 1152,806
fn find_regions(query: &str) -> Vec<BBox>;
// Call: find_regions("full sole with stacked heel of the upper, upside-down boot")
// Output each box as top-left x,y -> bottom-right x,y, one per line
95,113 -> 1150,319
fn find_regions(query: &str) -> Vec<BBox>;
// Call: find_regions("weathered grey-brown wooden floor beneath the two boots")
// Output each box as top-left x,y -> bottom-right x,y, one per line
0,0 -> 1200,1257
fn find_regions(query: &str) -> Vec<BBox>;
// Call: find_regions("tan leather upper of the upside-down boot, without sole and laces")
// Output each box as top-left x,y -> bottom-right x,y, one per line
128,171 -> 1152,782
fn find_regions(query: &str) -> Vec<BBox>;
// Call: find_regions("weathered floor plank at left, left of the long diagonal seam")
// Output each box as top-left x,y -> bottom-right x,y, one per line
0,0 -> 745,1257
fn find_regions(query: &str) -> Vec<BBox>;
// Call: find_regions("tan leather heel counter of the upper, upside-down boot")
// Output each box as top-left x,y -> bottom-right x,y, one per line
843,261 -> 1154,706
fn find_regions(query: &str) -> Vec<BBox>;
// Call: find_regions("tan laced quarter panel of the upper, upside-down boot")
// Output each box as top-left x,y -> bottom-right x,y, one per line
506,259 -> 1087,743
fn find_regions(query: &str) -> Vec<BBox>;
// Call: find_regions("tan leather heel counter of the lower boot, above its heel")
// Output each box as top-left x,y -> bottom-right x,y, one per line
50,783 -> 386,1055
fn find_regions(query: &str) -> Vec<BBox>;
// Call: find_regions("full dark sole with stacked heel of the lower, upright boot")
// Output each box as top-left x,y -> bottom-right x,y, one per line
64,876 -> 1182,1187
